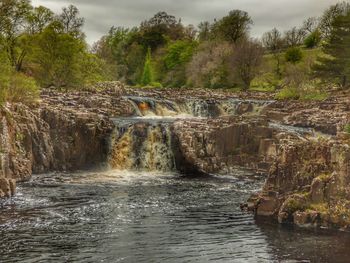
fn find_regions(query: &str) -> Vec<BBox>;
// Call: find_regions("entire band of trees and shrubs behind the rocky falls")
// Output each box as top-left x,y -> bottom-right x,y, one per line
0,0 -> 350,102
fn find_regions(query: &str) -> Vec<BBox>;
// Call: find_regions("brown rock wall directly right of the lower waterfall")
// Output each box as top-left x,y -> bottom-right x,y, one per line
174,117 -> 274,173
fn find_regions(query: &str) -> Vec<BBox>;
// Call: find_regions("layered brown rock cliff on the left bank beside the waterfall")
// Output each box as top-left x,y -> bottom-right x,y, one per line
0,83 -> 126,197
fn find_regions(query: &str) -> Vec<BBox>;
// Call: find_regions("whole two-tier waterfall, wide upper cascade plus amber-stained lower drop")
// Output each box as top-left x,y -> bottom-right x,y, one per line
109,96 -> 270,171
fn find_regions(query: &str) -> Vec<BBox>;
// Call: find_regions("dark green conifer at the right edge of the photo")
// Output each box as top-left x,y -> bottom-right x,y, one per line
315,10 -> 350,88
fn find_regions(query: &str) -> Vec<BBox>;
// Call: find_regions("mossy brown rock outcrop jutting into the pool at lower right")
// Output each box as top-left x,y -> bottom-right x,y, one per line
247,138 -> 350,231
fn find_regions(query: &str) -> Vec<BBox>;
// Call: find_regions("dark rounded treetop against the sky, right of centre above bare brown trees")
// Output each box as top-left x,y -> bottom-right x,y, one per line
213,10 -> 253,43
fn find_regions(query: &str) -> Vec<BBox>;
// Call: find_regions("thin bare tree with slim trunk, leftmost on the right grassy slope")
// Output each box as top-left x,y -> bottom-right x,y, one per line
262,28 -> 284,77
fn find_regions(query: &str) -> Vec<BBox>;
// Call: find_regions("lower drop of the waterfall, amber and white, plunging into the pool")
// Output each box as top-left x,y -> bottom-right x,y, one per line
109,119 -> 175,171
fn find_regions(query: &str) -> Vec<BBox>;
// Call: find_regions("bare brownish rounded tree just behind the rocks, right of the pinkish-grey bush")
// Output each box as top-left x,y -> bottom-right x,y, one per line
232,40 -> 264,90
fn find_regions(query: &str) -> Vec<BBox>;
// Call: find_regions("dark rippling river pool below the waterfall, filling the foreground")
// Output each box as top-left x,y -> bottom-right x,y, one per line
0,172 -> 350,262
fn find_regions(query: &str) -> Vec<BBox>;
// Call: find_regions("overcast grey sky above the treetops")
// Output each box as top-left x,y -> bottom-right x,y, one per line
32,0 -> 339,44
